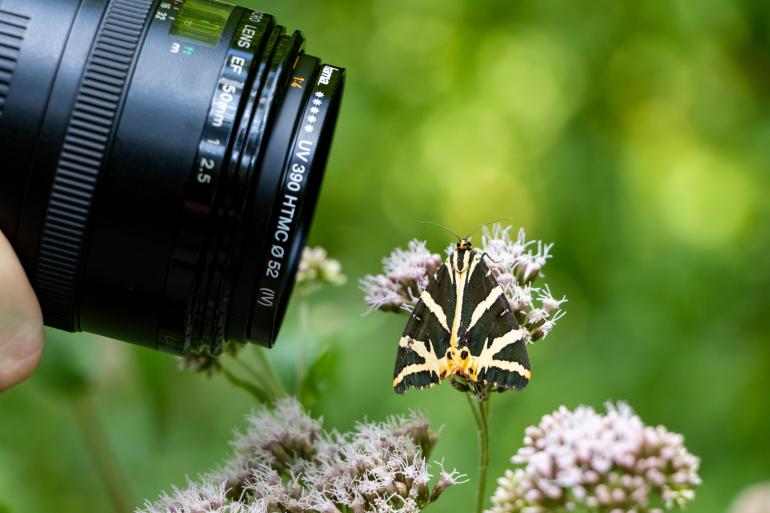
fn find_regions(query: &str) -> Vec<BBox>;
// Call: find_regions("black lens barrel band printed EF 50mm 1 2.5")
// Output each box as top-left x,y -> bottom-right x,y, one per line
160,11 -> 274,352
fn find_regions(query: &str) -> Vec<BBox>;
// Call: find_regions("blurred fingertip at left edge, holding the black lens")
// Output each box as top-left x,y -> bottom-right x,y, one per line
0,233 -> 43,392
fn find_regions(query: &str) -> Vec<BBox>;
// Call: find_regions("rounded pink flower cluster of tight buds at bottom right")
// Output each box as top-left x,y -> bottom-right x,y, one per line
488,403 -> 700,513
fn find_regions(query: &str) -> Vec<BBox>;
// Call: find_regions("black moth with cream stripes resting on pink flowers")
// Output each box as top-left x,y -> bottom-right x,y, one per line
393,239 -> 532,394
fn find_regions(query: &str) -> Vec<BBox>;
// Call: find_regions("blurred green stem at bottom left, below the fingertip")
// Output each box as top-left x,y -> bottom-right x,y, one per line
72,397 -> 133,513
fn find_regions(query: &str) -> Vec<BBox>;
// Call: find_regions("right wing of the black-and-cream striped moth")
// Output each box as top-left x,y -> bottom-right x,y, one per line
459,251 -> 531,390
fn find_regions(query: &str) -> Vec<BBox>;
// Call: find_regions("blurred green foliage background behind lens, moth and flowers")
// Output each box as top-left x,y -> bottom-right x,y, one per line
0,0 -> 770,513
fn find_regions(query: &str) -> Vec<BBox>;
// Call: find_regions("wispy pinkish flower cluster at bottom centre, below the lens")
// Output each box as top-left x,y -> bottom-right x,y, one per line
139,399 -> 462,513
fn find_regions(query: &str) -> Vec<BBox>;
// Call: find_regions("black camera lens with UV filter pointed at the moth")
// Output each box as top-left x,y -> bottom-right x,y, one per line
0,0 -> 345,354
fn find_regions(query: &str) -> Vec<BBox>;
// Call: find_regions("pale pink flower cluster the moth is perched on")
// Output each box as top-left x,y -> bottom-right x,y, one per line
360,224 -> 567,342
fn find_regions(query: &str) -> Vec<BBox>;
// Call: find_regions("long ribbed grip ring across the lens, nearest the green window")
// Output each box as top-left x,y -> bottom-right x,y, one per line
35,0 -> 154,331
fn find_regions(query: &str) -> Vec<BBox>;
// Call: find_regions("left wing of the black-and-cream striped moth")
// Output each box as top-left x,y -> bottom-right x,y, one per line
393,260 -> 455,394
